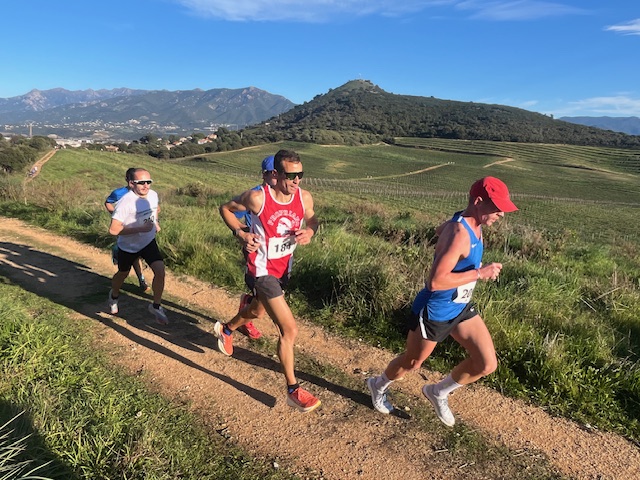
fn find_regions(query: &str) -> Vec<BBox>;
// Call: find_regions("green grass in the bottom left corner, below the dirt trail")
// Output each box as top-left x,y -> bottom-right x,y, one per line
0,284 -> 298,480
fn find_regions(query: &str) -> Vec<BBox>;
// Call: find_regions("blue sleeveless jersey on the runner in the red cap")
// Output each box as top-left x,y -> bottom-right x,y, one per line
411,212 -> 484,322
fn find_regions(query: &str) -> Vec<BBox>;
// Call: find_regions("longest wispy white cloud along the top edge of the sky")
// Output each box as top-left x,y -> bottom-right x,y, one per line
174,0 -> 456,23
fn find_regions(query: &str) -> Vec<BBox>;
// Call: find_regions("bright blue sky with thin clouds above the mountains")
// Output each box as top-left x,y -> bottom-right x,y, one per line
0,0 -> 640,117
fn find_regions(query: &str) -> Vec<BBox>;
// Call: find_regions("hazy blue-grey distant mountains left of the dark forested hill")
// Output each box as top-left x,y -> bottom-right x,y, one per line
0,87 -> 294,139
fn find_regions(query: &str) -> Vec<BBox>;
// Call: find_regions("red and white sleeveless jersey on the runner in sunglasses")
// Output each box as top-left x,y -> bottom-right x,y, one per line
247,185 -> 304,278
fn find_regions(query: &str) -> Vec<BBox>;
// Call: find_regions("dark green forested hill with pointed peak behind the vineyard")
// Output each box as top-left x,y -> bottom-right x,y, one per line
246,80 -> 640,147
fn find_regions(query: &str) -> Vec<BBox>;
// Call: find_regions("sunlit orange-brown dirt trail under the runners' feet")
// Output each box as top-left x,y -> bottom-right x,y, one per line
0,217 -> 640,480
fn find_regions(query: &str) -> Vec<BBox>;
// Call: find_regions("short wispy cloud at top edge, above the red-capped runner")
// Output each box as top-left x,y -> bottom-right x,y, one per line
456,0 -> 588,21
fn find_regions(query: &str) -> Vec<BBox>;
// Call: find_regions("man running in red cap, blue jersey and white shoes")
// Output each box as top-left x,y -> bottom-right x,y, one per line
367,177 -> 518,427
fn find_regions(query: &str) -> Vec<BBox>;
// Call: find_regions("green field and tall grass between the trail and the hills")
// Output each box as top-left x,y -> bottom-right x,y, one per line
1,139 -> 640,446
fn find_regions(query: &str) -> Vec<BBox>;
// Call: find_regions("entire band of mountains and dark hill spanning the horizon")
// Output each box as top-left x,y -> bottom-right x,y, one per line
0,80 -> 640,147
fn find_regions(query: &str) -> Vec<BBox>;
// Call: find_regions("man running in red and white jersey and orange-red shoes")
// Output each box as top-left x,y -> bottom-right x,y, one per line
219,150 -> 320,412
